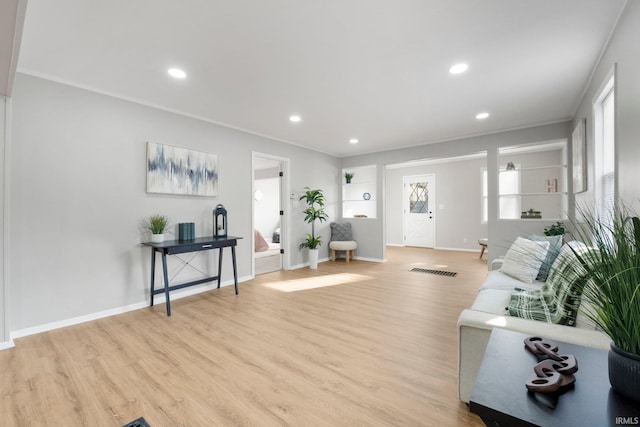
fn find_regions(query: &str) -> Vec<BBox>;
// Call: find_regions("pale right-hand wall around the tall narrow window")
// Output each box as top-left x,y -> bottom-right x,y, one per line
572,1 -> 640,209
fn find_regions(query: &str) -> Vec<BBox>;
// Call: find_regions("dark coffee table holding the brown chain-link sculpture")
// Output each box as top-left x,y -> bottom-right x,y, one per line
469,328 -> 640,427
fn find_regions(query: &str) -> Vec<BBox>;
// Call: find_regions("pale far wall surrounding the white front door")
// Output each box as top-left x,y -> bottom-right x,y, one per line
385,157 -> 487,251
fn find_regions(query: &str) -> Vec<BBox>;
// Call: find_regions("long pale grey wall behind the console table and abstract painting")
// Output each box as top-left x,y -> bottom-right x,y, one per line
9,74 -> 340,331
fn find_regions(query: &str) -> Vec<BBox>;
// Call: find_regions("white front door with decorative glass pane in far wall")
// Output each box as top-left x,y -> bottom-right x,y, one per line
403,174 -> 436,248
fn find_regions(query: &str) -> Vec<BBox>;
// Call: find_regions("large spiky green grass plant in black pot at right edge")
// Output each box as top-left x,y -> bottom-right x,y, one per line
575,204 -> 640,402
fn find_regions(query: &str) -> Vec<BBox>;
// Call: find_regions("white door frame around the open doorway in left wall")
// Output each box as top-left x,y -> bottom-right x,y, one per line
251,151 -> 291,277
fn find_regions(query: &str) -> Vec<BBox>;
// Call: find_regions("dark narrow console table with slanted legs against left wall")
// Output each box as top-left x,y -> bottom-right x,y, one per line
145,236 -> 242,316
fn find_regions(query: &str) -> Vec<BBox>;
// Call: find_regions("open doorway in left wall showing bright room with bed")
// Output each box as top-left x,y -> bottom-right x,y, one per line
252,153 -> 289,275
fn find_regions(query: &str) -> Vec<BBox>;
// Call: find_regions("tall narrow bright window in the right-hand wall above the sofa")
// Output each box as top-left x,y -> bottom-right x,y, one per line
593,76 -> 616,223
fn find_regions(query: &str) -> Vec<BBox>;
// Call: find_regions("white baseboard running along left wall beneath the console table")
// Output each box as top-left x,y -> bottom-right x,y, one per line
11,276 -> 251,342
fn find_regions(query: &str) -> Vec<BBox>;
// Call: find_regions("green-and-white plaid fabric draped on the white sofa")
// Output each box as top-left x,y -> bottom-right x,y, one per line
508,242 -> 586,326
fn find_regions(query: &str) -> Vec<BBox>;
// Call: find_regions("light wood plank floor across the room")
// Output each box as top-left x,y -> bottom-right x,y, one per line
0,247 -> 487,427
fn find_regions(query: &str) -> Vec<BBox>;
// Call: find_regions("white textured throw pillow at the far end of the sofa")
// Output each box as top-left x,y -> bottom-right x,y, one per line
500,237 -> 549,283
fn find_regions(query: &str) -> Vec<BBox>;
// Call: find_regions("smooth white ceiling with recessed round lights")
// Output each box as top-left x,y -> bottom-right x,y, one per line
11,0 -> 626,156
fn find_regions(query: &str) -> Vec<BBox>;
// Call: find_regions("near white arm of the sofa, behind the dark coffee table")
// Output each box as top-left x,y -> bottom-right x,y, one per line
458,310 -> 611,403
